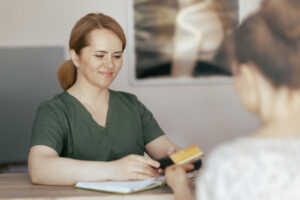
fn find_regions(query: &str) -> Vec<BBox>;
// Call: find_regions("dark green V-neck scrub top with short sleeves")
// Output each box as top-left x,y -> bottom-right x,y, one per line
31,90 -> 164,161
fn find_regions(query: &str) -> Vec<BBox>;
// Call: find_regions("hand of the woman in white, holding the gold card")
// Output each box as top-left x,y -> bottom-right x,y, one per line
165,164 -> 194,192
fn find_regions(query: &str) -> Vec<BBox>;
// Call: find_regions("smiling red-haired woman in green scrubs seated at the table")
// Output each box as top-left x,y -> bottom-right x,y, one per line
28,13 -> 179,185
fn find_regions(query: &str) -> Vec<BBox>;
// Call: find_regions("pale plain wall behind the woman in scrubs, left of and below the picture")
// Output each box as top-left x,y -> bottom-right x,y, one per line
0,0 -> 259,152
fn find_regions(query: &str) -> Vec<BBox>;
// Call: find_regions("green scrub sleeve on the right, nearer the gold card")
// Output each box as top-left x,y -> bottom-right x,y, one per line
137,96 -> 164,144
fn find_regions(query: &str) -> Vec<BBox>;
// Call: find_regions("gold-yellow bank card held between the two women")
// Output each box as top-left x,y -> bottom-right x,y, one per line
170,145 -> 203,165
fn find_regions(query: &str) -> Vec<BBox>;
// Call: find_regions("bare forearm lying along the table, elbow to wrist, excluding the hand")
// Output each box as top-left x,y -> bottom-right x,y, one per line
29,157 -> 113,185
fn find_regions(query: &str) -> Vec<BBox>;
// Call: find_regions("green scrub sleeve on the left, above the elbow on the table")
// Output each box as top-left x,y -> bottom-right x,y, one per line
31,104 -> 64,155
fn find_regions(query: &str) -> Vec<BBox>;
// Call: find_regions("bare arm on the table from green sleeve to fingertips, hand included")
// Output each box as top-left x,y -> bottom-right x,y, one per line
28,145 -> 159,185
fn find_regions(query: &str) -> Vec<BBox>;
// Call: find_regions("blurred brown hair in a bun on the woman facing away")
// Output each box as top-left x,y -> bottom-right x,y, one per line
233,0 -> 300,88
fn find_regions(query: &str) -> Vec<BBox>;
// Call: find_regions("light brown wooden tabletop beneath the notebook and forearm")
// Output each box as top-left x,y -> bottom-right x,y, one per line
0,173 -> 174,200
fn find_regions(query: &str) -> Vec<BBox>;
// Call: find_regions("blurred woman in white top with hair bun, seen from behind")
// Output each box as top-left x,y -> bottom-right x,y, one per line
166,0 -> 300,200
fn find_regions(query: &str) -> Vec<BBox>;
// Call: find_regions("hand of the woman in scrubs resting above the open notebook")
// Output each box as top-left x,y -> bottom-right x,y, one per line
111,154 -> 160,180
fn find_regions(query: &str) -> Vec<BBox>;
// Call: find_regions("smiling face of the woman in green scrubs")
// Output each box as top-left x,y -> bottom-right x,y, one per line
77,29 -> 123,89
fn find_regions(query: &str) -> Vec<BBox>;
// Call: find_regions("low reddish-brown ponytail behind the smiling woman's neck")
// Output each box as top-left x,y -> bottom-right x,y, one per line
57,60 -> 77,90
